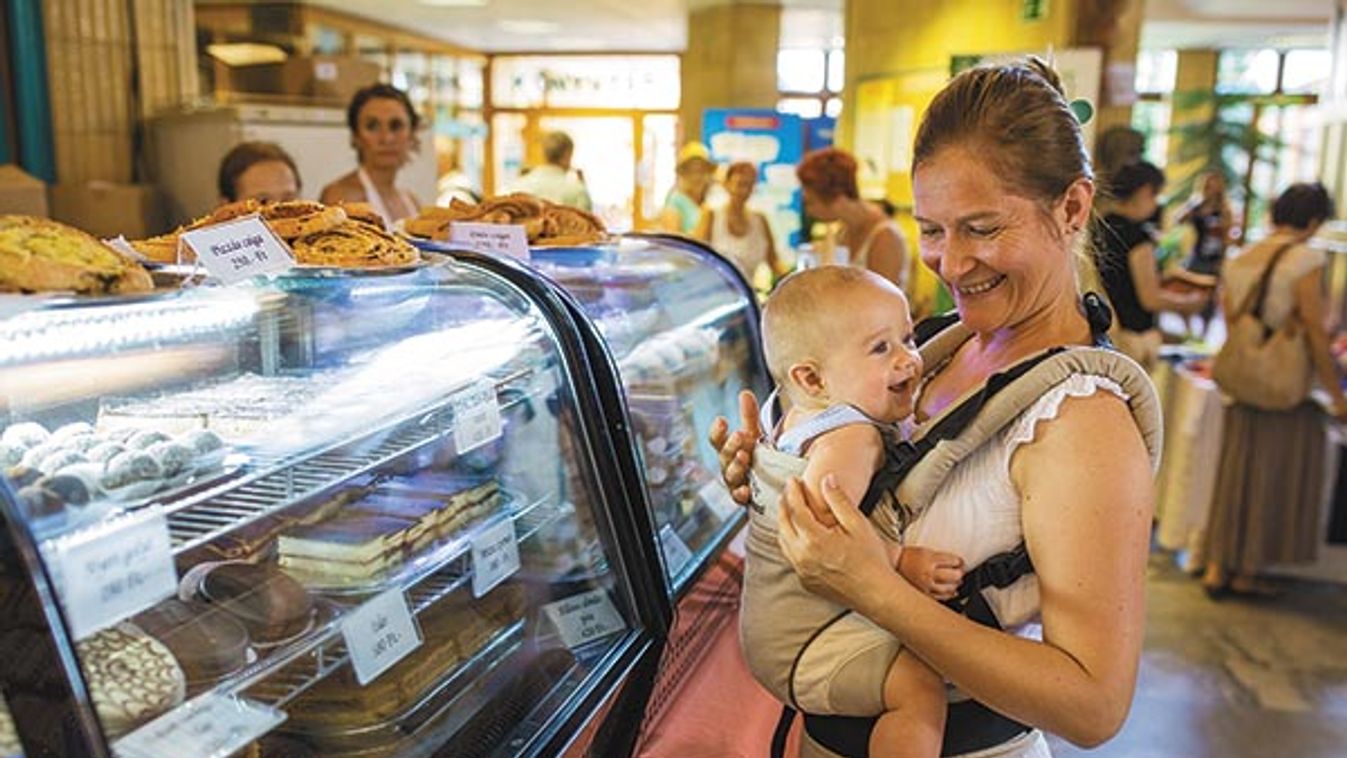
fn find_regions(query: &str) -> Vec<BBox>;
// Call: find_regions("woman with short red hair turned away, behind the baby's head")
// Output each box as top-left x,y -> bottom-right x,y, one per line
795,147 -> 908,289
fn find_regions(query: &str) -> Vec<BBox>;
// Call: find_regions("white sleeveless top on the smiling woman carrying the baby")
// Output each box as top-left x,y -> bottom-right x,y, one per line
904,373 -> 1130,630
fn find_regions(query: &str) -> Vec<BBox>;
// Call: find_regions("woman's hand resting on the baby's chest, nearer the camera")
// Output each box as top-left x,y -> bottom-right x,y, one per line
777,474 -> 902,615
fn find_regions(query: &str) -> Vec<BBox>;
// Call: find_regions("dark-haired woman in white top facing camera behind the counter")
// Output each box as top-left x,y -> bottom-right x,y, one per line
318,83 -> 420,225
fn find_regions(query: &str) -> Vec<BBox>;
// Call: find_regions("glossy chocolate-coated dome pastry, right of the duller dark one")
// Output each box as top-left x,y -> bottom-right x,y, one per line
197,561 -> 315,646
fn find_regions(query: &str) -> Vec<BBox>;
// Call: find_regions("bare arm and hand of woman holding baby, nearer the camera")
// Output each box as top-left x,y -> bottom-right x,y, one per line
780,394 -> 1153,746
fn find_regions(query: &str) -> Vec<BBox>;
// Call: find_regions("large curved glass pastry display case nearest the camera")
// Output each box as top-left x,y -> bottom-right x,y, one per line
0,256 -> 668,758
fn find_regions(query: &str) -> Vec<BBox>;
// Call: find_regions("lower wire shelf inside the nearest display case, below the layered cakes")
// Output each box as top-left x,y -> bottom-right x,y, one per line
110,495 -> 562,753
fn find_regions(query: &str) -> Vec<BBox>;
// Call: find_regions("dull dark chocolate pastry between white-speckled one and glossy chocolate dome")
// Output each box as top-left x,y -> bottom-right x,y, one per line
133,599 -> 249,695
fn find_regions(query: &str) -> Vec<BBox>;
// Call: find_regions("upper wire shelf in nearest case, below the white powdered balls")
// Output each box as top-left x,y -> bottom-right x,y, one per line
164,369 -> 533,555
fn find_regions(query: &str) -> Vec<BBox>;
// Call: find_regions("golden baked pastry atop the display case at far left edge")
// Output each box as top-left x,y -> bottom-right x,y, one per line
0,215 -> 154,295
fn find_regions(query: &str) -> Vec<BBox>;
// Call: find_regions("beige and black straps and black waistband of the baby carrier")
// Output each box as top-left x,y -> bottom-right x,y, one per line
772,292 -> 1161,757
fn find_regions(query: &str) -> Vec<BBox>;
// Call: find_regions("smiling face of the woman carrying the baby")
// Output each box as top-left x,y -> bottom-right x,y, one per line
912,145 -> 1090,334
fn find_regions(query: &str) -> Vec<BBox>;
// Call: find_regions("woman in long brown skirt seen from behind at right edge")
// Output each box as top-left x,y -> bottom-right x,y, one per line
1202,184 -> 1347,596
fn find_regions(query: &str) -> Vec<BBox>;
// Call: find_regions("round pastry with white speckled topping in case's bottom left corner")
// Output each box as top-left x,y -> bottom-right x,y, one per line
75,623 -> 187,738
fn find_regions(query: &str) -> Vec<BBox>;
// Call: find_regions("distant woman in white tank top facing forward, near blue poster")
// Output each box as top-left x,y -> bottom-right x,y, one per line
692,162 -> 788,284
